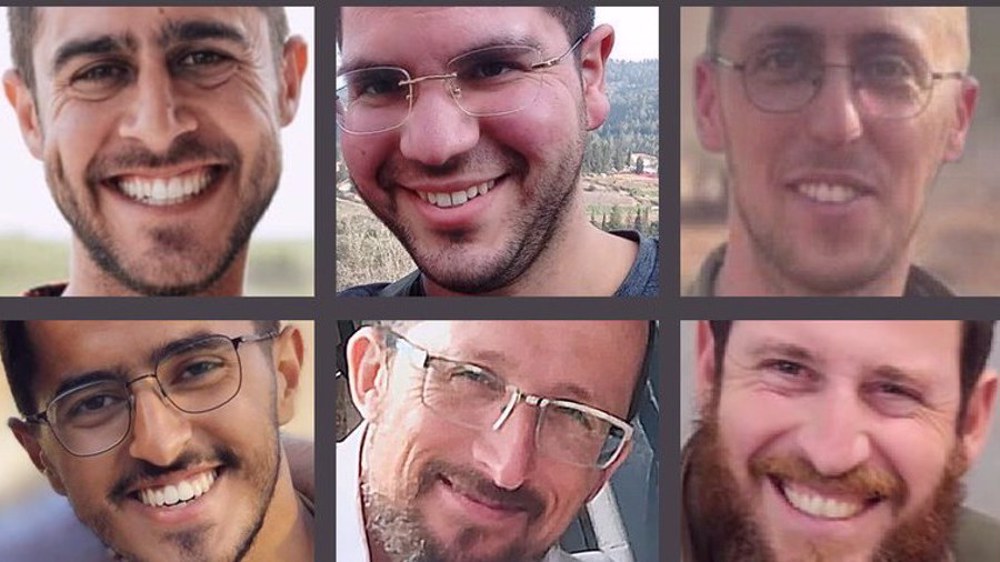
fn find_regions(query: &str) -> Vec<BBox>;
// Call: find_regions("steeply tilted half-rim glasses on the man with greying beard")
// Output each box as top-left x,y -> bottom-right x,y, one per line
385,330 -> 633,469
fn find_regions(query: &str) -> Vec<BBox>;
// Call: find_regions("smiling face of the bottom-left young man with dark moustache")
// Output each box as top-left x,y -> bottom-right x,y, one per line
12,321 -> 296,561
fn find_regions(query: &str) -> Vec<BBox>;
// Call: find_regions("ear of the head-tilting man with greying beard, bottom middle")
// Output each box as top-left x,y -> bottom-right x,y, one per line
347,326 -> 389,421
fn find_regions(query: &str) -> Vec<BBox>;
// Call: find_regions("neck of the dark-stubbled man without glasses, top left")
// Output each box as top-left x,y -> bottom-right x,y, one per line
63,237 -> 247,297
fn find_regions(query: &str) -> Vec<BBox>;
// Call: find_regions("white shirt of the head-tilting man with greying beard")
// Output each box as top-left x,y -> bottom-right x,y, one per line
336,423 -> 613,562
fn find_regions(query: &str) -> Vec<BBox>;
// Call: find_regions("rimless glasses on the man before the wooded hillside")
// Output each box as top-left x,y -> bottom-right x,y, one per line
337,33 -> 589,135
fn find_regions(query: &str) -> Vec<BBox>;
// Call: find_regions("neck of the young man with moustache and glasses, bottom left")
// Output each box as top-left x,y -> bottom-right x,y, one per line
244,452 -> 314,562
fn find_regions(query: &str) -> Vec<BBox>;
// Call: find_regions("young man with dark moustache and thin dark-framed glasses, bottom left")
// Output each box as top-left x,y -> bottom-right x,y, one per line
0,321 -> 313,561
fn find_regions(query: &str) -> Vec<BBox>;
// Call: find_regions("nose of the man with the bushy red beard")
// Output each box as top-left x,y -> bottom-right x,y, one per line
798,380 -> 871,476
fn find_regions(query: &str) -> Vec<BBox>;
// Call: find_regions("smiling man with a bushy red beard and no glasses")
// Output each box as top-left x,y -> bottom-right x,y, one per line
682,320 -> 1000,562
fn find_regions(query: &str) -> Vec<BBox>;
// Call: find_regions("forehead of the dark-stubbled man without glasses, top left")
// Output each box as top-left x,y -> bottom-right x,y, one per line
35,6 -> 267,55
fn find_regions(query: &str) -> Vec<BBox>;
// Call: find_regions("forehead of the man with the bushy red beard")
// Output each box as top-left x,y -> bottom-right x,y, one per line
727,320 -> 961,378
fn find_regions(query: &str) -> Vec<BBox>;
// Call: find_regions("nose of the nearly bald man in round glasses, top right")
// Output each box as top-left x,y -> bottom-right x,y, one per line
806,64 -> 863,146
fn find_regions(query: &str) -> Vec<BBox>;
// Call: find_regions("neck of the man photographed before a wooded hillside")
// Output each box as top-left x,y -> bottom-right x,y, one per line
421,196 -> 639,297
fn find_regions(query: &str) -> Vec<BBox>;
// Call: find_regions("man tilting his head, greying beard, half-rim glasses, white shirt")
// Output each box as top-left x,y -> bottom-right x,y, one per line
337,321 -> 658,562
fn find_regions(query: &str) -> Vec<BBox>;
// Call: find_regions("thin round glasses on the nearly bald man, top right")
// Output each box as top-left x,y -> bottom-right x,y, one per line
711,47 -> 966,119
